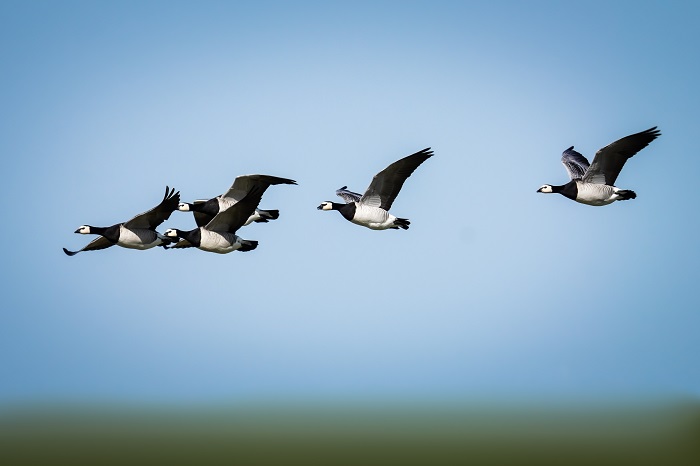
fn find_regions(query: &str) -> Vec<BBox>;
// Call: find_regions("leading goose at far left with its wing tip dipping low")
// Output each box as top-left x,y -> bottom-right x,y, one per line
63,186 -> 180,256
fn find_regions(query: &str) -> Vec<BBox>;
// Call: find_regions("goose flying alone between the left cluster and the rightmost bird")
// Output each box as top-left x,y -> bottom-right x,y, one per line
318,147 -> 433,230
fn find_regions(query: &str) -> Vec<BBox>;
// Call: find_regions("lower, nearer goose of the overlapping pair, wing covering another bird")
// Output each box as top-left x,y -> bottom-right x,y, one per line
165,175 -> 288,254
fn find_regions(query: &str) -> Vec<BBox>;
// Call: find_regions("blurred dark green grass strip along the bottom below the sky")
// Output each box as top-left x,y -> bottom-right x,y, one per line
0,403 -> 700,466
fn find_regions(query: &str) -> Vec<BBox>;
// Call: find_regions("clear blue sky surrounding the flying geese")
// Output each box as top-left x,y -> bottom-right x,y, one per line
0,1 -> 700,403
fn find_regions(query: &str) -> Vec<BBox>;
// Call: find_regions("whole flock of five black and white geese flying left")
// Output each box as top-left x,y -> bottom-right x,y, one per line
63,127 -> 661,256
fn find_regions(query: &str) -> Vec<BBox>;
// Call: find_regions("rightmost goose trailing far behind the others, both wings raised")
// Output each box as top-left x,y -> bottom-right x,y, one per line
537,126 -> 661,206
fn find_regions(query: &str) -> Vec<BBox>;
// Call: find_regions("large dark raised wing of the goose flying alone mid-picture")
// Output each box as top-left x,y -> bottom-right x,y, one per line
361,147 -> 433,210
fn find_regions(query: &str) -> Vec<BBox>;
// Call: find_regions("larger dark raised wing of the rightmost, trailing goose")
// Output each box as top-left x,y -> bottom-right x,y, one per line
583,126 -> 661,186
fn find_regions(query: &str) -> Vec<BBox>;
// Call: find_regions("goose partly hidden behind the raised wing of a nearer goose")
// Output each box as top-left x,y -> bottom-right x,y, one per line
177,175 -> 297,227
